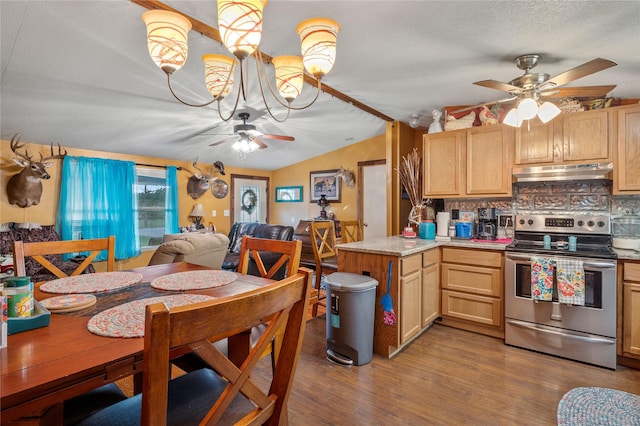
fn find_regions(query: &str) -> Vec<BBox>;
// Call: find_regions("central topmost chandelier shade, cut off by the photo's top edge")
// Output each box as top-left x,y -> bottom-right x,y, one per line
218,0 -> 267,60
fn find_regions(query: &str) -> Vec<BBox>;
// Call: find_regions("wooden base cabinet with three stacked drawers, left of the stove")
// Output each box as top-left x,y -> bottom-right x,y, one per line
440,247 -> 504,338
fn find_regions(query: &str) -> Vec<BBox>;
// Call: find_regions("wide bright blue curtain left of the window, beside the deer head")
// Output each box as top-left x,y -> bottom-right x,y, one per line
56,156 -> 141,260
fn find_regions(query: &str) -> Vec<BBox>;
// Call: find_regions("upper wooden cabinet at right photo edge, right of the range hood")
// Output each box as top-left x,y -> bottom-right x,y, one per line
611,105 -> 640,194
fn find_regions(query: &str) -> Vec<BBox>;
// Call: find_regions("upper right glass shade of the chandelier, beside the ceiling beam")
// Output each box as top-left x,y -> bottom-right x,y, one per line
297,18 -> 340,80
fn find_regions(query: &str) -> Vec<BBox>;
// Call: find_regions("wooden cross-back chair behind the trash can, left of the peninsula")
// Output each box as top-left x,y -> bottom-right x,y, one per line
311,220 -> 338,317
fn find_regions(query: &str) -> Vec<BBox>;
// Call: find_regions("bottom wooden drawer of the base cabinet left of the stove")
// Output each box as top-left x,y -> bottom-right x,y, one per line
442,290 -> 502,327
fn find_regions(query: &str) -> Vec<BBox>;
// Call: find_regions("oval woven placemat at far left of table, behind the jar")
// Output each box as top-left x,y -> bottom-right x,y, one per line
40,272 -> 142,294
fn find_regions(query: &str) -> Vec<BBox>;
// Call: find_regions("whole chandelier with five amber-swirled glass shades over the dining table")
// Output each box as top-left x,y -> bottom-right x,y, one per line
142,0 -> 340,122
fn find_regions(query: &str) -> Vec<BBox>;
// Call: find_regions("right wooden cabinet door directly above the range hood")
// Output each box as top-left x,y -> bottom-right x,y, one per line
562,110 -> 611,162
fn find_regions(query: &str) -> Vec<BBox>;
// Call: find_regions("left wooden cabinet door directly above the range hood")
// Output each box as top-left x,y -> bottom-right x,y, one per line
514,122 -> 554,165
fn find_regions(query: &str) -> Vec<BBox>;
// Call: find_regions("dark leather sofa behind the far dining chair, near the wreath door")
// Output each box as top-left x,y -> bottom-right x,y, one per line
222,222 -> 294,279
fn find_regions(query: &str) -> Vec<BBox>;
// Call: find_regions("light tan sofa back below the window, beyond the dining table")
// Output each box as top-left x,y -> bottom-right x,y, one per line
149,232 -> 229,269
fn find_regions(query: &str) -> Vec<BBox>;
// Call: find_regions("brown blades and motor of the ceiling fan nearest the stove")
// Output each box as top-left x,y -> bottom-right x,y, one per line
454,54 -> 617,112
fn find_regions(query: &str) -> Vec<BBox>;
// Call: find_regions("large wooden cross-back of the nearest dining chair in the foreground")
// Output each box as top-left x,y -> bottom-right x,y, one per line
142,268 -> 311,425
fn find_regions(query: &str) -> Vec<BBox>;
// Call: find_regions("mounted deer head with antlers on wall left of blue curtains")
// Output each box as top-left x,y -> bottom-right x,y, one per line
7,135 -> 67,208
